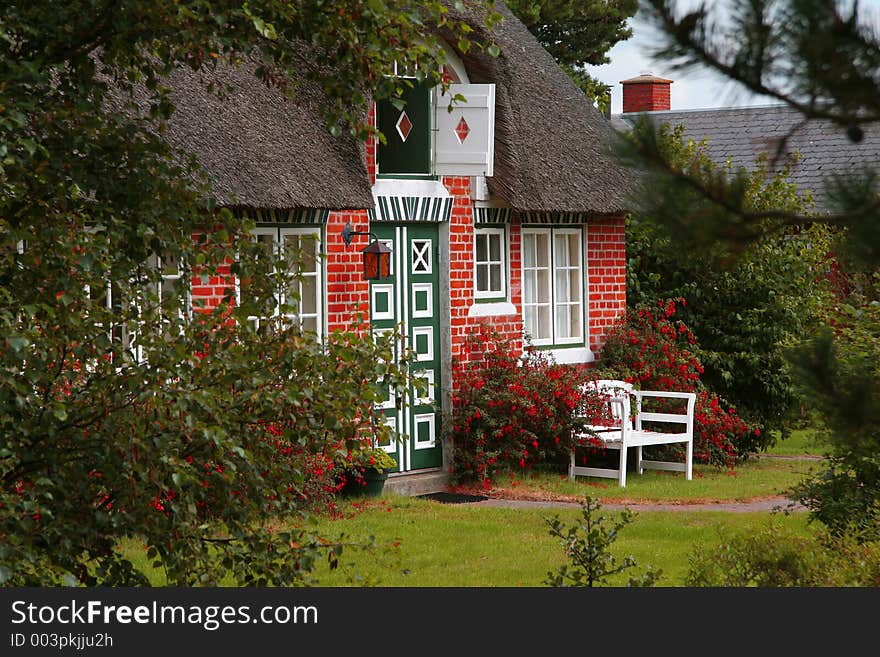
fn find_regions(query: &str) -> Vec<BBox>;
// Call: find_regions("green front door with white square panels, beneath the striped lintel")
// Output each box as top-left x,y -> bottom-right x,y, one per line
370,223 -> 443,472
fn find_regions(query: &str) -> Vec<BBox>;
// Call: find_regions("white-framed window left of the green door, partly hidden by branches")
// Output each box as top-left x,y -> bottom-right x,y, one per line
239,226 -> 324,335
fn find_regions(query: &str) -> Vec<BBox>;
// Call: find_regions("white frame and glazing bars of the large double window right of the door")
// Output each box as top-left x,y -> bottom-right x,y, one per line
521,226 -> 587,347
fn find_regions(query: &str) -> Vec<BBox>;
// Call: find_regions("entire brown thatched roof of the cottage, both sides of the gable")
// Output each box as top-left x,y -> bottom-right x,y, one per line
111,2 -> 634,214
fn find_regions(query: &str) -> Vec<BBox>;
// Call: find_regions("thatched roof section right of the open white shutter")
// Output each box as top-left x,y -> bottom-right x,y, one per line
450,2 -> 635,214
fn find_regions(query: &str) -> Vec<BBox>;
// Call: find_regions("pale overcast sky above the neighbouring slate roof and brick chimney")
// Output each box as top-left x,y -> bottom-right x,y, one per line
588,0 -> 880,114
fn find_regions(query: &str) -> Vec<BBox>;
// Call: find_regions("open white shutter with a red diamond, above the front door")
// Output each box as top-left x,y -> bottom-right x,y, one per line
434,84 -> 495,176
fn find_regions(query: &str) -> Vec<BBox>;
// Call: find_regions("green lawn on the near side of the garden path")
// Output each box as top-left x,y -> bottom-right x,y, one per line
306,496 -> 812,587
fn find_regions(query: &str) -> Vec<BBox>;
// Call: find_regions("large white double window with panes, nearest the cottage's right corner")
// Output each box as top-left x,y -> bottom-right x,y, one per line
522,227 -> 584,345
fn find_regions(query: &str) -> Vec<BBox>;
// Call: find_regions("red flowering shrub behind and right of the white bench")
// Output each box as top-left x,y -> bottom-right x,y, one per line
601,299 -> 760,467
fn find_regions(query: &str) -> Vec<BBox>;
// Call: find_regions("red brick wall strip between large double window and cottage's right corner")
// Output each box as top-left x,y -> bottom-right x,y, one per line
587,216 -> 626,356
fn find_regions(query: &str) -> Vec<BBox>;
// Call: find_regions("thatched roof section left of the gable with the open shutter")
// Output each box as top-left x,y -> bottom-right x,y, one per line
123,52 -> 373,210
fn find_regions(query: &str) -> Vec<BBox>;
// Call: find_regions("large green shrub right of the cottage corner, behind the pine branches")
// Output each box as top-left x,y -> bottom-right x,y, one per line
626,126 -> 830,441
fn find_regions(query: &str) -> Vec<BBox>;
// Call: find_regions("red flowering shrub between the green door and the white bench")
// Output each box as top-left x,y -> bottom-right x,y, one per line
450,326 -> 589,487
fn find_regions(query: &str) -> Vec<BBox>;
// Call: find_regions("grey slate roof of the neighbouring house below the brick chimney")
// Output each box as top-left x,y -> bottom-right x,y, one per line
612,105 -> 880,212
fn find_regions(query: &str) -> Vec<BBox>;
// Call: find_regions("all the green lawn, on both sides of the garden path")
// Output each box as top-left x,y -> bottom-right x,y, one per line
121,431 -> 822,587
